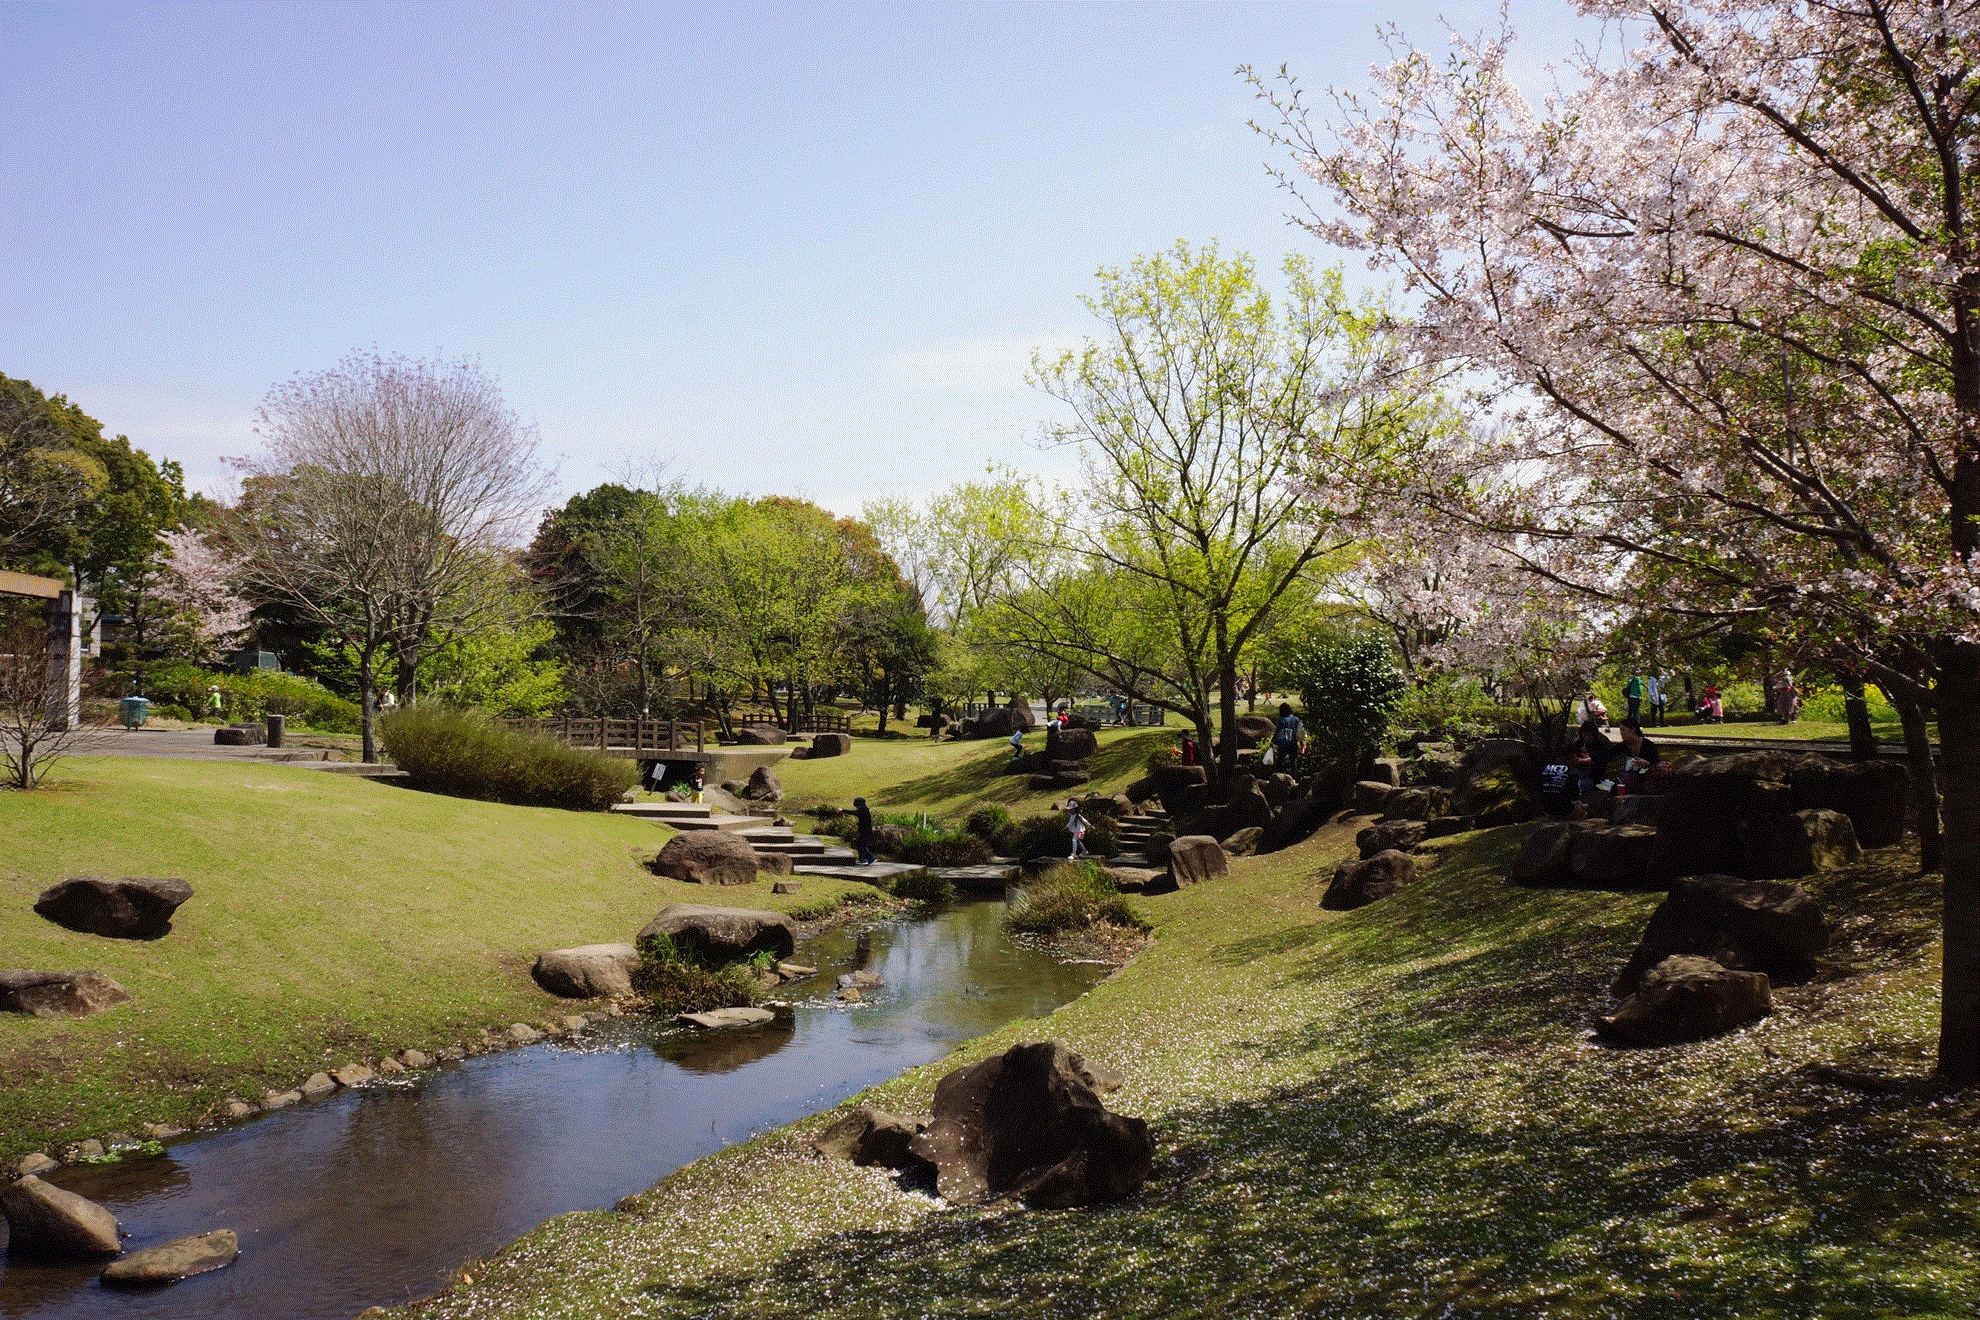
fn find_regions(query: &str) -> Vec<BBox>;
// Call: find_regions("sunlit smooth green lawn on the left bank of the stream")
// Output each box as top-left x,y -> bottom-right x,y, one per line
0,758 -> 883,1154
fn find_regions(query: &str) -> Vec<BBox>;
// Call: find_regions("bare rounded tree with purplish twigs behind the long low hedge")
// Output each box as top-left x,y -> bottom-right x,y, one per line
228,352 -> 545,760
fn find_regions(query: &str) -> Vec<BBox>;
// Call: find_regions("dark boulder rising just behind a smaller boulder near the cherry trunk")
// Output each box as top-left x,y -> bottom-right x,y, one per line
1614,875 -> 1835,999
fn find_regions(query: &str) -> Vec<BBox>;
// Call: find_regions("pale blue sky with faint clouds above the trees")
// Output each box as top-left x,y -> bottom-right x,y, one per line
0,0 -> 1578,526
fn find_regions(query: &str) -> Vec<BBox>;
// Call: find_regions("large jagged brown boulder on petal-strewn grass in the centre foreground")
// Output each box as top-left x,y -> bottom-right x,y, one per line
909,1041 -> 1154,1209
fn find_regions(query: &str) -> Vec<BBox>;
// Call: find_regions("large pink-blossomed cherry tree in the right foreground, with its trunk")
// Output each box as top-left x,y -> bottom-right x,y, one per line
1263,0 -> 1980,1083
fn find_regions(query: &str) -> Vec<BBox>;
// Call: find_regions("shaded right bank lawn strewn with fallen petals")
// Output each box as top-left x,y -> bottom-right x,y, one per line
394,827 -> 1980,1320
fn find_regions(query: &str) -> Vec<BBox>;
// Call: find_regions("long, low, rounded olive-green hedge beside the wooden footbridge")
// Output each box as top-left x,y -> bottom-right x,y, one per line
378,703 -> 638,811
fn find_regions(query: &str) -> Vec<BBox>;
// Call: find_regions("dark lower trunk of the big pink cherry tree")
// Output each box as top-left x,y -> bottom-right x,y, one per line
1921,639 -> 1980,1086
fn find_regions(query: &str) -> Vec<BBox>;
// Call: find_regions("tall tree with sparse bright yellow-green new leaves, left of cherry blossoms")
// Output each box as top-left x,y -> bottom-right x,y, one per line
1002,243 -> 1412,778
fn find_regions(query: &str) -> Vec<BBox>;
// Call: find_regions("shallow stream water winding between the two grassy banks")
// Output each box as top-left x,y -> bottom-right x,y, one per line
0,902 -> 1105,1320
